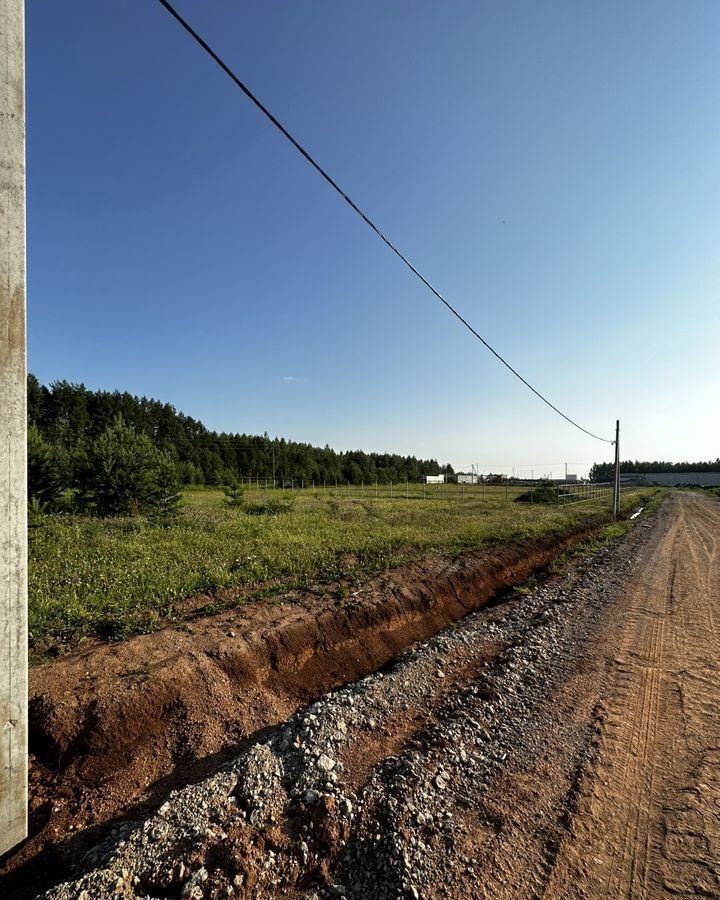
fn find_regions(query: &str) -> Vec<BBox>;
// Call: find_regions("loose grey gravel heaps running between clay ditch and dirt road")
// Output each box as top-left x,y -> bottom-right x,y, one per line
43,529 -> 646,900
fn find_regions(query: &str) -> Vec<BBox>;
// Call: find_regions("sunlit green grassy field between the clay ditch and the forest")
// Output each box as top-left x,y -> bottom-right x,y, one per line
29,485 -> 654,658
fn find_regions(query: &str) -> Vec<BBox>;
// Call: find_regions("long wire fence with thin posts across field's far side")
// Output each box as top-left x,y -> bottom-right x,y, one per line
229,477 -> 637,507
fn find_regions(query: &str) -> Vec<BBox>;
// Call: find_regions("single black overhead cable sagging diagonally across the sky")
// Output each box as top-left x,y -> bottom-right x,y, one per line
159,0 -> 614,444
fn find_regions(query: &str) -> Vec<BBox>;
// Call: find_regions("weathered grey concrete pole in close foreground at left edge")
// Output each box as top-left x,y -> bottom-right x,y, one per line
0,0 -> 28,854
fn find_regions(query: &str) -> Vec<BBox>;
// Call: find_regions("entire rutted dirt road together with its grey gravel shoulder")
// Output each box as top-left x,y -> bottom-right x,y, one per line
36,494 -> 720,900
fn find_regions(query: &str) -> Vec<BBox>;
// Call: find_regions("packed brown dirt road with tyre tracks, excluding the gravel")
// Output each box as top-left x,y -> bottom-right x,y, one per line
547,494 -> 720,900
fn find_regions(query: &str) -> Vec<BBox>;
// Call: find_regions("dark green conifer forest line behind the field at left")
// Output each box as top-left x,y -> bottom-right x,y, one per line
28,375 -> 453,506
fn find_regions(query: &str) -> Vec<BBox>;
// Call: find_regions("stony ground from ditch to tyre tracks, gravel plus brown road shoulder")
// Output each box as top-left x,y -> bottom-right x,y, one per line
38,506 -> 655,900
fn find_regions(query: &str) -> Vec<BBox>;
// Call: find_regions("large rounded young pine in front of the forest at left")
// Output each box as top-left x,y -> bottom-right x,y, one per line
79,416 -> 180,517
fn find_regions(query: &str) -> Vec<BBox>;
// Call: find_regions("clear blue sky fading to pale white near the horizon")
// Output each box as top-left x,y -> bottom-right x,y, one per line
27,0 -> 720,475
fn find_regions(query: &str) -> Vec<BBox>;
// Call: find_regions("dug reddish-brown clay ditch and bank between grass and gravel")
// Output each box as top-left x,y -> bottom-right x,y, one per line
0,530 -> 589,896
